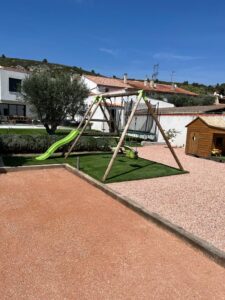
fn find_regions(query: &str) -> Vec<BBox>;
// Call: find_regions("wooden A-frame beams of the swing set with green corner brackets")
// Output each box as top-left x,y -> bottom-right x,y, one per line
65,90 -> 184,182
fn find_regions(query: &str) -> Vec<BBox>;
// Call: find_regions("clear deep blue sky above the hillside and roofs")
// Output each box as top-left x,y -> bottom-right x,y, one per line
0,0 -> 225,84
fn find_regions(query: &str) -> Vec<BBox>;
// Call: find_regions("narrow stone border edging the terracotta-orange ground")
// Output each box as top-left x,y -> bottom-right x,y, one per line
0,164 -> 225,267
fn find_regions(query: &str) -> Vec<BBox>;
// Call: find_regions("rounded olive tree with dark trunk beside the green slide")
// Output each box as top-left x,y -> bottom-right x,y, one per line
22,71 -> 89,134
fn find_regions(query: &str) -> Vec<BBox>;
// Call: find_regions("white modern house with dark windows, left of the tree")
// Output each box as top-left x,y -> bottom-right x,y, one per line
0,66 -> 31,119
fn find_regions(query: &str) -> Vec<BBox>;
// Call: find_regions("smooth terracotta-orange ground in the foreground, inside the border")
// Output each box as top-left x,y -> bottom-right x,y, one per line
0,169 -> 225,300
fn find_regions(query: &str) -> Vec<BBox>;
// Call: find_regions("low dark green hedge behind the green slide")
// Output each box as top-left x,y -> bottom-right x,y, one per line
0,134 -> 111,154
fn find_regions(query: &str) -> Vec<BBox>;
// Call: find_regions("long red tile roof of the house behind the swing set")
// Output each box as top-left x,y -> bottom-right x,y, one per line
85,75 -> 197,96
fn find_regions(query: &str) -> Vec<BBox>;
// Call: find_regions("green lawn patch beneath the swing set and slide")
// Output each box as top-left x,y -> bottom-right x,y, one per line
3,154 -> 186,183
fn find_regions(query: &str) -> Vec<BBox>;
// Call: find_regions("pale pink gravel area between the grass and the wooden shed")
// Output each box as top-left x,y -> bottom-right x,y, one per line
109,146 -> 225,250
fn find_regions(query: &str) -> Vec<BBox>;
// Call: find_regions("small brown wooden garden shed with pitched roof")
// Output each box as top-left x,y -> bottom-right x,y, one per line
185,116 -> 225,157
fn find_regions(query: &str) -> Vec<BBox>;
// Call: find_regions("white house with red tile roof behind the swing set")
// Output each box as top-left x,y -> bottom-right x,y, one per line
83,74 -> 196,140
